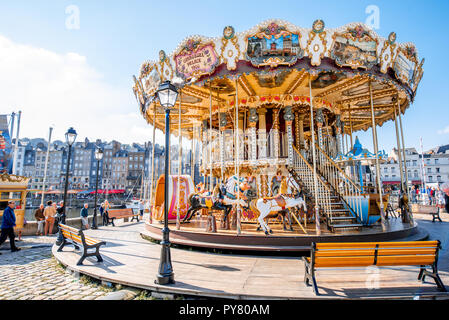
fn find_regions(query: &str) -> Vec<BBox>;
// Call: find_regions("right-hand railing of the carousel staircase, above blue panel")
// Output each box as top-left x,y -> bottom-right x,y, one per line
315,144 -> 362,221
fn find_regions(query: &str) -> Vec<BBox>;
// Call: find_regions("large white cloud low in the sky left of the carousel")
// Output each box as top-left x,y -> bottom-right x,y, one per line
0,35 -> 158,143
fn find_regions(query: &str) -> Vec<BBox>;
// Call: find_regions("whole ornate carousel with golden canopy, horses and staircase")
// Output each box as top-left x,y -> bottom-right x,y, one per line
133,20 -> 424,251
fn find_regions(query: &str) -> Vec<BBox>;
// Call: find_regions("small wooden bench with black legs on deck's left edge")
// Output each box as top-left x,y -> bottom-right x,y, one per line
58,224 -> 106,265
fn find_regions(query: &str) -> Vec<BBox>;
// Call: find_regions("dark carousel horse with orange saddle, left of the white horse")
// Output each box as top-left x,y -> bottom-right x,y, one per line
182,176 -> 249,222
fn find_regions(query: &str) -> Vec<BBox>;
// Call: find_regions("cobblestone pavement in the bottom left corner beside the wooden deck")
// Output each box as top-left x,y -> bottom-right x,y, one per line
0,236 -> 113,300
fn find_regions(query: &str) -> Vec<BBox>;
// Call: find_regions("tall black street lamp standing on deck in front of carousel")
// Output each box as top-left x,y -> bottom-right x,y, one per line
156,81 -> 178,284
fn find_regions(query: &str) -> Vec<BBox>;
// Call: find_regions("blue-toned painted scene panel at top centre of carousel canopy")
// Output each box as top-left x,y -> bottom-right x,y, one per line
246,23 -> 304,67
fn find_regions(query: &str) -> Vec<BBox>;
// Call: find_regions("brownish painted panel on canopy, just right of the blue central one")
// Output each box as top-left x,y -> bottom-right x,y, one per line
331,26 -> 377,69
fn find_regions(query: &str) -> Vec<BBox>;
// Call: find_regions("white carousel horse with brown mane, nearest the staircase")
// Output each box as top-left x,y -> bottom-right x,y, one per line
250,178 -> 307,235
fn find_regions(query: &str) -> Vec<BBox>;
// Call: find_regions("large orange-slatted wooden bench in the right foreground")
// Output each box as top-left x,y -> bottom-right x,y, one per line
303,240 -> 446,295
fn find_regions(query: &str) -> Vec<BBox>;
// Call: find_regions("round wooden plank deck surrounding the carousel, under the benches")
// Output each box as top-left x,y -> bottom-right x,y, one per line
53,214 -> 449,299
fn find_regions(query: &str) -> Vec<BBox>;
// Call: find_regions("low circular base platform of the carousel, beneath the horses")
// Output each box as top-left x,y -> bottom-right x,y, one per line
141,218 -> 428,252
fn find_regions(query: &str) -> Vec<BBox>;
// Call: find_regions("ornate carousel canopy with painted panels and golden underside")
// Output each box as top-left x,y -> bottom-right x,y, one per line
133,20 -> 424,137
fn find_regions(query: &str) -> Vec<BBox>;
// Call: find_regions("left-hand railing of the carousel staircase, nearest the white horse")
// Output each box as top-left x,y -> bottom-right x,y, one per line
293,146 -> 332,220
